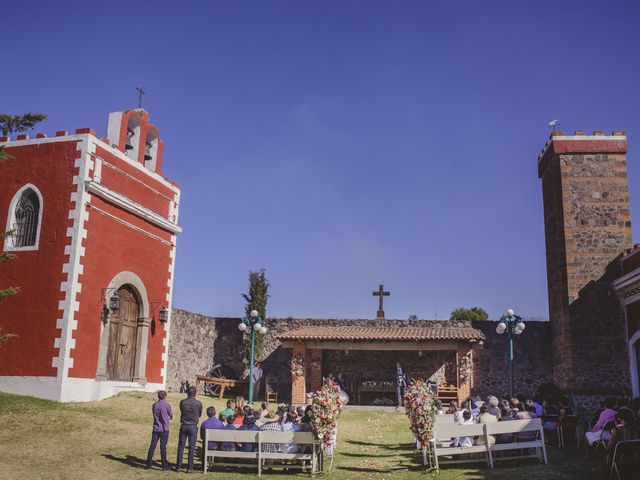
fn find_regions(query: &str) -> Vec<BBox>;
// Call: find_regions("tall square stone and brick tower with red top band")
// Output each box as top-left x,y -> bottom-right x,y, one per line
538,132 -> 632,404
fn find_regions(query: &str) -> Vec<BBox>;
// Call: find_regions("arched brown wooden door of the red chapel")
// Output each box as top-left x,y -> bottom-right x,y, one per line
107,285 -> 138,381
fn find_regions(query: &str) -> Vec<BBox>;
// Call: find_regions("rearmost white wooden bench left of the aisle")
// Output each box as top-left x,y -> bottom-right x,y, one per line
203,429 -> 323,475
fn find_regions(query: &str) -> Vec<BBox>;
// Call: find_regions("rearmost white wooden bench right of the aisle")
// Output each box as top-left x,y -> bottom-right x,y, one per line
423,415 -> 547,470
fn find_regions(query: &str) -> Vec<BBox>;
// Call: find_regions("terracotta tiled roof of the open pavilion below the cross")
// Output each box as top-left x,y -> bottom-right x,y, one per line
278,326 -> 485,341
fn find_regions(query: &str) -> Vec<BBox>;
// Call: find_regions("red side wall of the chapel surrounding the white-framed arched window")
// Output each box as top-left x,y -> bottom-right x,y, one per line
0,140 -> 79,376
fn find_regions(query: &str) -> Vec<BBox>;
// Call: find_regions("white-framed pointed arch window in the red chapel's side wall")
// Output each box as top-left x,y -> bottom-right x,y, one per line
4,185 -> 42,250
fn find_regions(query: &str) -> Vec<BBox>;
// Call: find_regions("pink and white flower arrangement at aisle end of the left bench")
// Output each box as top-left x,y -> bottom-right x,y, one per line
309,382 -> 342,455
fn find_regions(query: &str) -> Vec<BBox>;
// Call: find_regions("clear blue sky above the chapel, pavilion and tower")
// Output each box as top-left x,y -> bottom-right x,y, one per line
5,1 -> 640,318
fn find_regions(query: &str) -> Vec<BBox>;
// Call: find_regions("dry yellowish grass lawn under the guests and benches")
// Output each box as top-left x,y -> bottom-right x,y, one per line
0,393 -> 601,480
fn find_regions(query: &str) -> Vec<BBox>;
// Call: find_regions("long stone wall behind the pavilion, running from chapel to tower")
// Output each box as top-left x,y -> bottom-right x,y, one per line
168,309 -> 552,400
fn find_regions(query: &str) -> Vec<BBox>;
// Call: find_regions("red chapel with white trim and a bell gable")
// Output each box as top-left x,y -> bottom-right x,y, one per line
0,109 -> 181,401
